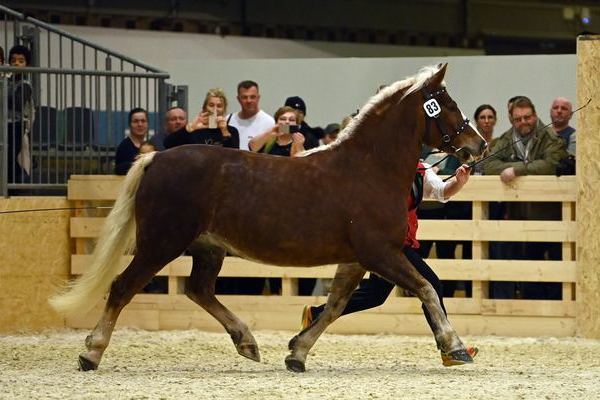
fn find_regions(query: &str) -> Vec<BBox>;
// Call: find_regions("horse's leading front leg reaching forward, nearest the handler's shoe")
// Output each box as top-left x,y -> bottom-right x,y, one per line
368,249 -> 473,363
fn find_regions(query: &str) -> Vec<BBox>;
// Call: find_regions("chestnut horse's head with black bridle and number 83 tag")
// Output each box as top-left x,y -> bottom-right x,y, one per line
420,64 -> 487,162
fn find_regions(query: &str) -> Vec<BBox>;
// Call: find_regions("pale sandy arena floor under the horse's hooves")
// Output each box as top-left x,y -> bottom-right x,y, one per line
0,329 -> 600,400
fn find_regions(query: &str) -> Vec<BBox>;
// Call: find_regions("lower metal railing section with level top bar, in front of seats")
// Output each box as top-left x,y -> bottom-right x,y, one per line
0,67 -> 168,194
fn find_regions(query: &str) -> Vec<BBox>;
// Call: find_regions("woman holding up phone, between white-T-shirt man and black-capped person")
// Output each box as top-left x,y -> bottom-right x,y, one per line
250,106 -> 304,157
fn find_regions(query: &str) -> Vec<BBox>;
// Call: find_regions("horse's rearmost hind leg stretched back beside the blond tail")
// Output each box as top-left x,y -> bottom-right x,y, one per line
79,250 -> 183,371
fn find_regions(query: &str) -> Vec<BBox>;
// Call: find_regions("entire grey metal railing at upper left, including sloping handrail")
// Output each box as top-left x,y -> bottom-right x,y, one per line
0,5 -> 181,196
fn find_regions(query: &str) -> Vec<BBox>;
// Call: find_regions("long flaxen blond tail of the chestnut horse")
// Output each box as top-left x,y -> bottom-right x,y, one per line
49,152 -> 156,315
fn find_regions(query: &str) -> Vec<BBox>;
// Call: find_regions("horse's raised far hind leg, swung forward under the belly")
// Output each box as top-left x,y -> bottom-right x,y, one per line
185,243 -> 260,361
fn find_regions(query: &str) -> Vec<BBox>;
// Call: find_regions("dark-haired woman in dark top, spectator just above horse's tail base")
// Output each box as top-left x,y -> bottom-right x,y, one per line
115,108 -> 148,175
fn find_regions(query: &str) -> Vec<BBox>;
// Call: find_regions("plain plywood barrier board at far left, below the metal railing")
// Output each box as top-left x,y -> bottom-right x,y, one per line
0,196 -> 71,333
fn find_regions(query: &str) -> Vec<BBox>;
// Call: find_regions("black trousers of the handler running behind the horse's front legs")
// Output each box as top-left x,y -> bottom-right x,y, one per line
312,246 -> 446,332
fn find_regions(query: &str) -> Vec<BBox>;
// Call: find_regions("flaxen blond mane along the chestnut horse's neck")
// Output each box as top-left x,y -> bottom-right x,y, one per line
297,64 -> 444,157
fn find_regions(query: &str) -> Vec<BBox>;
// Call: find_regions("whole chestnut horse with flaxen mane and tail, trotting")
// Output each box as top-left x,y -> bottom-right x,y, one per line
50,64 -> 486,371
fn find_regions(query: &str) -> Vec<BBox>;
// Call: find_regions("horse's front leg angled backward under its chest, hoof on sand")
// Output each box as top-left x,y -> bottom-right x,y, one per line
285,264 -> 366,372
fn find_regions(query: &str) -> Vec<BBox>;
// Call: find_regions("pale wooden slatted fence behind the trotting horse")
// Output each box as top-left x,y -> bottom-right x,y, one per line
67,176 -> 577,336
